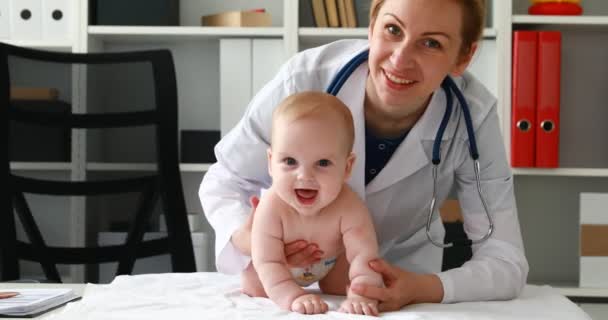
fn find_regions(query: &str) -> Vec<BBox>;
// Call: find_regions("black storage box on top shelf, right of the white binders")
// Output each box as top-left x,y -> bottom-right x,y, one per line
91,0 -> 179,26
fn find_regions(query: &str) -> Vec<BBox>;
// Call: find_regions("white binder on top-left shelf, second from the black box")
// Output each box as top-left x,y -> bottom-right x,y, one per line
9,0 -> 42,40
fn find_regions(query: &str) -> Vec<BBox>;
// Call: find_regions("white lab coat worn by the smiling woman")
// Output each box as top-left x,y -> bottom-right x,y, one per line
199,40 -> 528,302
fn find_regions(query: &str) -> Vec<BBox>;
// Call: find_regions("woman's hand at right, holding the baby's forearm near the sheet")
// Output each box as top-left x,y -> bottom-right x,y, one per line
350,259 -> 443,312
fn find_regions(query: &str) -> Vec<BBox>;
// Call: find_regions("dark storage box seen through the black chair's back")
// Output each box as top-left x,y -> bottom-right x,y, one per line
9,100 -> 71,162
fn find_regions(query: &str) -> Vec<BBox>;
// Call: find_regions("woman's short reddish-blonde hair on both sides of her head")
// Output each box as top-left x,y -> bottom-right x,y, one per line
369,0 -> 486,55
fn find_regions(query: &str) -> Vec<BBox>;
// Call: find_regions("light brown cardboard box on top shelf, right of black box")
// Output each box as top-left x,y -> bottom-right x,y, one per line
201,10 -> 272,27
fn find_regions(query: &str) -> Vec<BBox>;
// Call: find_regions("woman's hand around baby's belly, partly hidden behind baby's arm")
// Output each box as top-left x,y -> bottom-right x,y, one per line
231,196 -> 323,267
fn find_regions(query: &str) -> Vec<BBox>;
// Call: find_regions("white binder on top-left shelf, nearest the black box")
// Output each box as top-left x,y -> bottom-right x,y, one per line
42,0 -> 73,40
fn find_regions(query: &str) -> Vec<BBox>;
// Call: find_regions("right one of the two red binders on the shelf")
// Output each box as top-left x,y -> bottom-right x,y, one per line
536,31 -> 562,168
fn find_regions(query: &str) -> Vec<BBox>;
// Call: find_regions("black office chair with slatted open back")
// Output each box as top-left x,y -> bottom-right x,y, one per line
0,43 -> 196,282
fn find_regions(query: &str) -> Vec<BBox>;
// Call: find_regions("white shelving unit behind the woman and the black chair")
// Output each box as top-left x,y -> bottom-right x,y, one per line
3,0 -> 608,312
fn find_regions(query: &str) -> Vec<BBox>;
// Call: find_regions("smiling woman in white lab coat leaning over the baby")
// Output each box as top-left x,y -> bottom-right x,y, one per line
199,0 -> 528,311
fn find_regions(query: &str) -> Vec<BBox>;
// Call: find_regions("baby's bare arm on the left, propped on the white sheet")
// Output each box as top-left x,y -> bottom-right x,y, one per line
251,191 -> 306,310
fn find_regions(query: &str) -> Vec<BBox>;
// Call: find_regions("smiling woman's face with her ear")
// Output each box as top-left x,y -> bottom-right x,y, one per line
366,0 -> 472,120
